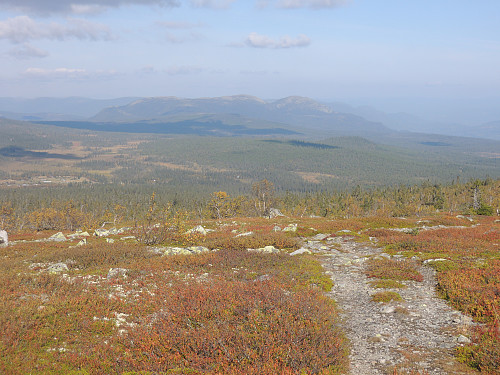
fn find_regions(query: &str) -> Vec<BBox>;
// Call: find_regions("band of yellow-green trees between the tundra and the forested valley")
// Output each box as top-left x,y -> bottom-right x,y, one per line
0,178 -> 500,231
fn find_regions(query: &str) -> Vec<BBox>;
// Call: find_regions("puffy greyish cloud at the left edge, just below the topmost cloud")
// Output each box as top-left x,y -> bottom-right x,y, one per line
0,16 -> 112,43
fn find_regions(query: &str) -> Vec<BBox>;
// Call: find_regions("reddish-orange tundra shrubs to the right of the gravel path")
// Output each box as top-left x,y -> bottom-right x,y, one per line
369,216 -> 500,374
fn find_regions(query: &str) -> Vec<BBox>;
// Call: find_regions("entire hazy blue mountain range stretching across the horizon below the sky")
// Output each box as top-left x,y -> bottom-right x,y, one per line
0,95 -> 500,140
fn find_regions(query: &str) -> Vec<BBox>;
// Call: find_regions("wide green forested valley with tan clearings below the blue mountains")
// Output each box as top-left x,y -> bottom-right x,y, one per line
0,120 -> 500,194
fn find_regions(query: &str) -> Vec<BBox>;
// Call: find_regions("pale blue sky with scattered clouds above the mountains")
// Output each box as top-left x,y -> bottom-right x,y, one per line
0,0 -> 500,120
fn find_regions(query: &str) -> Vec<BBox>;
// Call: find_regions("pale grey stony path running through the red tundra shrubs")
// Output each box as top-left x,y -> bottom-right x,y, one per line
304,237 -> 476,375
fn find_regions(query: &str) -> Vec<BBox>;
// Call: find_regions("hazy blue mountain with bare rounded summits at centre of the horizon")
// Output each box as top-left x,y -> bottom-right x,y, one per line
90,95 -> 392,136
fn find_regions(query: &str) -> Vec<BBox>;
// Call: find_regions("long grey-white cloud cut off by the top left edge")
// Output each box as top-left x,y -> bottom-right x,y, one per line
0,0 -> 180,14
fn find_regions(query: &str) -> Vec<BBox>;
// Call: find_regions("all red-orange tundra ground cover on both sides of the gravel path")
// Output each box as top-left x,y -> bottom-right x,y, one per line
0,182 -> 500,375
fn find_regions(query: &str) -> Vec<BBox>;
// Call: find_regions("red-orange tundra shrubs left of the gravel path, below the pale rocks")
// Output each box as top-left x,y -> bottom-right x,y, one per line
0,234 -> 348,374
